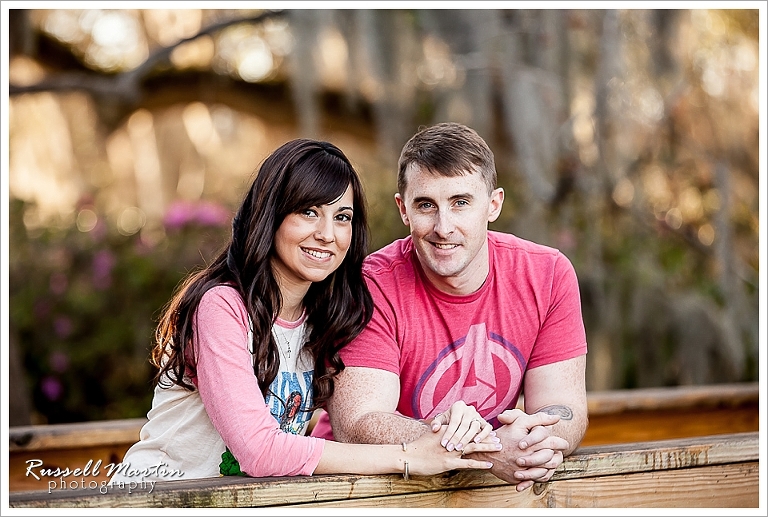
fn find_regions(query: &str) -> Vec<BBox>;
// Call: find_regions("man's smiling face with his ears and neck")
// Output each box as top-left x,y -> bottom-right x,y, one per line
395,164 -> 504,294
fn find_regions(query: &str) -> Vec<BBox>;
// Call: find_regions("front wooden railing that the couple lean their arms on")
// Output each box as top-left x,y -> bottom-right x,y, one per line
9,432 -> 759,508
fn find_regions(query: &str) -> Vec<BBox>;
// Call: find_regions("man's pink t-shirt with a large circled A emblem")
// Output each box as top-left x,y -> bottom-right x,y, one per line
312,232 -> 587,438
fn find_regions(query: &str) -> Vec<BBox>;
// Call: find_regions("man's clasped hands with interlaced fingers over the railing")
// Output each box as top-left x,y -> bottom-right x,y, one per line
468,409 -> 569,492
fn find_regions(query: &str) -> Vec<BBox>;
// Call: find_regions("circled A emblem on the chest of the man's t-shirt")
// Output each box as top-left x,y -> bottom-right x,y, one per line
411,323 -> 525,418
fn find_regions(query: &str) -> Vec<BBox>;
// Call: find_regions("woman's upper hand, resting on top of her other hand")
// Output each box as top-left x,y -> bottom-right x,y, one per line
430,400 -> 499,454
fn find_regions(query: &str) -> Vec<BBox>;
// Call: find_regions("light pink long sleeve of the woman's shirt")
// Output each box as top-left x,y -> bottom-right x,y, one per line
195,286 -> 325,477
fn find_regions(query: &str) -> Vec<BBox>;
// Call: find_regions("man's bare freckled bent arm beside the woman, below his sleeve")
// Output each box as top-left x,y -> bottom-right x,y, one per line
328,367 -> 430,444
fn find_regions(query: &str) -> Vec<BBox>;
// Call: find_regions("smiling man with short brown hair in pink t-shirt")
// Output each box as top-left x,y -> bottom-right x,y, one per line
313,123 -> 588,491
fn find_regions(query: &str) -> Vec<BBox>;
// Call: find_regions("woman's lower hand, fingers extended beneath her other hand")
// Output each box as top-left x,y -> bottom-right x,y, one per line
401,433 -> 501,476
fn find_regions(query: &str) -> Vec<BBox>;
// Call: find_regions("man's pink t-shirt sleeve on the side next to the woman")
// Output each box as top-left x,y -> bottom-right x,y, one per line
339,275 -> 400,375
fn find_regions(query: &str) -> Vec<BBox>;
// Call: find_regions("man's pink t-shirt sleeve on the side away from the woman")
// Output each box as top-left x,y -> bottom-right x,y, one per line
528,253 -> 587,368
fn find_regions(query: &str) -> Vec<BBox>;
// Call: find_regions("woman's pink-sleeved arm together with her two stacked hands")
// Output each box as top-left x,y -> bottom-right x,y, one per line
195,287 -> 500,477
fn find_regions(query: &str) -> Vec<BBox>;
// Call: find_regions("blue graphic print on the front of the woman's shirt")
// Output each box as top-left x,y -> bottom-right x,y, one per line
267,371 -> 314,434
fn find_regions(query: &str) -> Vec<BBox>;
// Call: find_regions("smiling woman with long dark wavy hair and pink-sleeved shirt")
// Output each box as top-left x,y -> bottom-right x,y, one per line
111,139 -> 500,483
